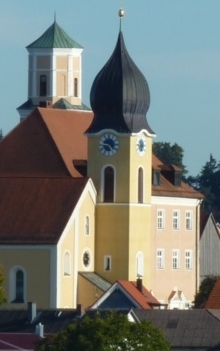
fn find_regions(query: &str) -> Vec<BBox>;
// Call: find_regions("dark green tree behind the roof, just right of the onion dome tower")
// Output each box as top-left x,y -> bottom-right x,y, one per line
153,142 -> 188,177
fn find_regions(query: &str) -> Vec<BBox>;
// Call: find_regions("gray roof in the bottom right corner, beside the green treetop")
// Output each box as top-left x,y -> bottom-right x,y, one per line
132,309 -> 220,349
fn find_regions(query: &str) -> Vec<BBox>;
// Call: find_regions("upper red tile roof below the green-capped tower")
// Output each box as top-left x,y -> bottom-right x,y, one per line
0,108 -> 92,177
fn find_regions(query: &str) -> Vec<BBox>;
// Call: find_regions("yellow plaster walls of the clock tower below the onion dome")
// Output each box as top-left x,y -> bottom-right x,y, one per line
88,130 -> 152,285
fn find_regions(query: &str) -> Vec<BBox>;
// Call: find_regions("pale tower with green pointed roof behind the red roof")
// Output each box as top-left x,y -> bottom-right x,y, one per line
17,20 -> 84,120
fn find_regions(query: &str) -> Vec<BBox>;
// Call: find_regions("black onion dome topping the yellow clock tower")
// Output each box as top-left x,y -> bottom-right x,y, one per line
87,32 -> 154,134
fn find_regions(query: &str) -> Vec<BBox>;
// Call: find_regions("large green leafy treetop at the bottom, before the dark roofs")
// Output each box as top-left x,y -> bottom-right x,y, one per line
36,313 -> 170,351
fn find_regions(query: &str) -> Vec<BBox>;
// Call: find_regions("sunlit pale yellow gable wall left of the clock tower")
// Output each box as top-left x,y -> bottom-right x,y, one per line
57,184 -> 95,308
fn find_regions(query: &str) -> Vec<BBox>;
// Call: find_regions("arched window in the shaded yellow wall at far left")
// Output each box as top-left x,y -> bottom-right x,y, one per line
10,267 -> 25,303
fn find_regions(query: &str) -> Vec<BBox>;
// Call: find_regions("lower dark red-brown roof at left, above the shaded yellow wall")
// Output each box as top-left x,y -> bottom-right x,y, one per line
0,177 -> 88,244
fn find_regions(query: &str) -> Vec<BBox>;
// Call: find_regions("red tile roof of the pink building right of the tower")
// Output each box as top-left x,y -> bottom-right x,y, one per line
152,155 -> 204,199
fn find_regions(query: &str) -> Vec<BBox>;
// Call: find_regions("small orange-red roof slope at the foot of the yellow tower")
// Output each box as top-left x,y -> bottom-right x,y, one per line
117,280 -> 160,309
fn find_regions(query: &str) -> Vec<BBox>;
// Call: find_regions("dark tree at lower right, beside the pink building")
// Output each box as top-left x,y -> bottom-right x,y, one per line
194,277 -> 217,308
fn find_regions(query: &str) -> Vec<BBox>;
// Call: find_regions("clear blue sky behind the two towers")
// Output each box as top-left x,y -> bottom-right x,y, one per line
0,0 -> 220,175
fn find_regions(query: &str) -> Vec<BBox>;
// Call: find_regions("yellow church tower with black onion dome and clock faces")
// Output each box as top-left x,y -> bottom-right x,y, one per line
87,10 -> 155,286
